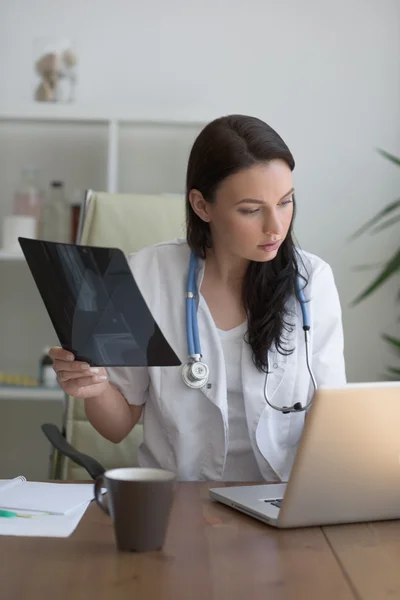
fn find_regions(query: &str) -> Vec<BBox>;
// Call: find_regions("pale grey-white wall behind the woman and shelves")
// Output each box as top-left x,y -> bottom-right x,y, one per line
0,0 -> 400,381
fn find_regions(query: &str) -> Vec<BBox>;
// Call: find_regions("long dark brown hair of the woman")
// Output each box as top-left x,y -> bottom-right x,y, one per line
186,115 -> 306,371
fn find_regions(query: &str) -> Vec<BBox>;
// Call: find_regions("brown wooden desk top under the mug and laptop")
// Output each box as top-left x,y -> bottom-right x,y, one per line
0,482 -> 400,600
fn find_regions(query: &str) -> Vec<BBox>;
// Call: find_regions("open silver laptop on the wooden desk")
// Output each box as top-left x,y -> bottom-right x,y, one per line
209,382 -> 400,528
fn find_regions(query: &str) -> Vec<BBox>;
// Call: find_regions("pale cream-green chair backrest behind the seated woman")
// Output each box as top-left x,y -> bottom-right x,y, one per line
62,191 -> 185,480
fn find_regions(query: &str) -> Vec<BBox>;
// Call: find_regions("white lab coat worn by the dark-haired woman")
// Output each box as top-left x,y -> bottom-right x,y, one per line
108,240 -> 346,481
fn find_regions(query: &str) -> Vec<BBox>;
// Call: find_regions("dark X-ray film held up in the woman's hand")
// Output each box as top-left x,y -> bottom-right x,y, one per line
18,237 -> 181,367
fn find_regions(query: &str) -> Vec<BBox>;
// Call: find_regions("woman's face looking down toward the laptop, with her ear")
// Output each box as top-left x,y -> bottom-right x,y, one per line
190,160 -> 294,262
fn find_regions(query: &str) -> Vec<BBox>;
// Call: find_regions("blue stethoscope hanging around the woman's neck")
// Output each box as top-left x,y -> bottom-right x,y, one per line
182,252 -> 317,414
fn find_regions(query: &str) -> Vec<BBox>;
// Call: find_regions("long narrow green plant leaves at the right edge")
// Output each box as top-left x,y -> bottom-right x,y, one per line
350,149 -> 400,379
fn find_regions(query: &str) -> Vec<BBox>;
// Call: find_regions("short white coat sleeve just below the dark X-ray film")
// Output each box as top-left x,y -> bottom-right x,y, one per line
107,367 -> 150,406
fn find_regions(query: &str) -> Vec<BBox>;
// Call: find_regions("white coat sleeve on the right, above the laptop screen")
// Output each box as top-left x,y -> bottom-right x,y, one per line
310,263 -> 346,387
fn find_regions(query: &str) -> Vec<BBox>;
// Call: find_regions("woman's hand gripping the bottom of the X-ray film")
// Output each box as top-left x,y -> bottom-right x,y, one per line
49,346 -> 109,398
